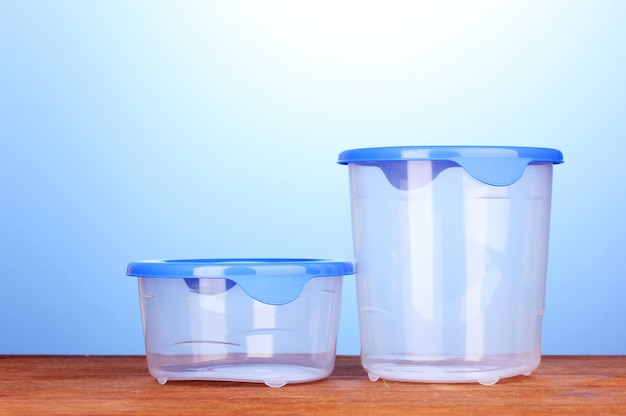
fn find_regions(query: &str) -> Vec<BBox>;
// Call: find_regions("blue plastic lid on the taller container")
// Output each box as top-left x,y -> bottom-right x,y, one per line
337,146 -> 563,186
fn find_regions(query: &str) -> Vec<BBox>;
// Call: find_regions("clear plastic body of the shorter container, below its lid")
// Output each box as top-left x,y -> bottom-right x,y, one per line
139,276 -> 342,387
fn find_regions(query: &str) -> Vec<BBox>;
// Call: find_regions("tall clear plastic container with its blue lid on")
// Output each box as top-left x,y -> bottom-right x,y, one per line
338,146 -> 563,384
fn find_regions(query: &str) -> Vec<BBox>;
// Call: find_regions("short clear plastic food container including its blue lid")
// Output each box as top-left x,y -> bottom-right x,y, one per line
127,259 -> 353,387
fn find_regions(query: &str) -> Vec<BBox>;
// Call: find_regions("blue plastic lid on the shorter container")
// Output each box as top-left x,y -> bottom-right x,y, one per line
126,259 -> 354,305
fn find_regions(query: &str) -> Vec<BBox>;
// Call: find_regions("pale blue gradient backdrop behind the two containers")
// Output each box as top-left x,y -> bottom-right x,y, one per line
0,0 -> 626,354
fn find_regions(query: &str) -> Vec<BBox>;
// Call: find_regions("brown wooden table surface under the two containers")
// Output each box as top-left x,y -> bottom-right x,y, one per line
0,356 -> 626,416
